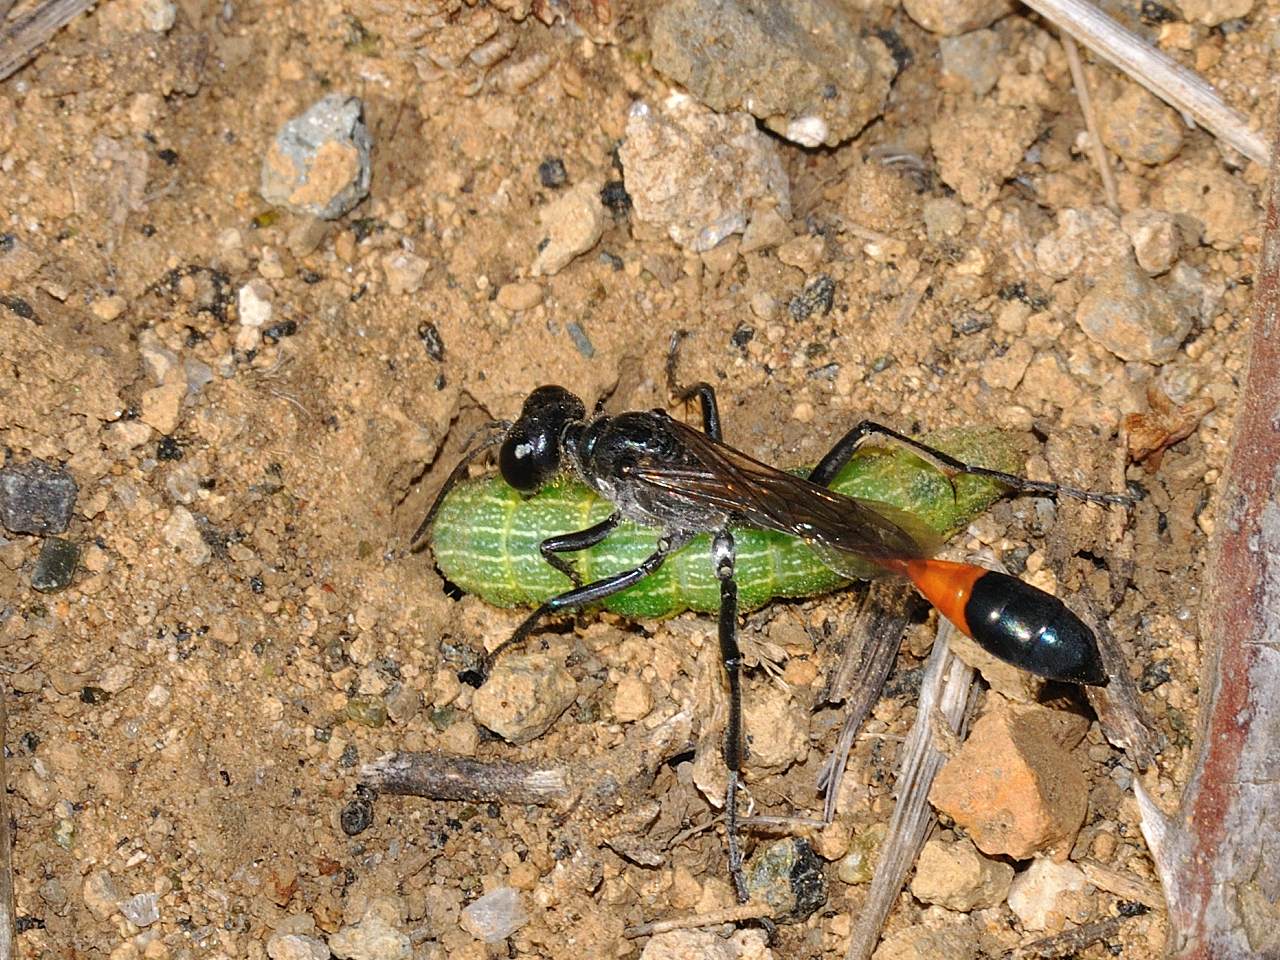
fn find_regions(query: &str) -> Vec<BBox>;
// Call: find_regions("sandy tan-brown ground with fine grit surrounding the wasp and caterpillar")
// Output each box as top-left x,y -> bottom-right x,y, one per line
0,0 -> 1276,959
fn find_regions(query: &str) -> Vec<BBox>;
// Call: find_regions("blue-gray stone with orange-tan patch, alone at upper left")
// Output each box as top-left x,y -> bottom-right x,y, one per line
261,93 -> 372,220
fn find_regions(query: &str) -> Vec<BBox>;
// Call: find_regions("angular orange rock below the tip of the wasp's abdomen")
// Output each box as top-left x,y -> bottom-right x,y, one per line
929,694 -> 1089,860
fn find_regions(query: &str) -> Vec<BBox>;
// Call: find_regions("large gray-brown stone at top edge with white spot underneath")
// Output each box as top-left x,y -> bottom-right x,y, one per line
652,0 -> 895,147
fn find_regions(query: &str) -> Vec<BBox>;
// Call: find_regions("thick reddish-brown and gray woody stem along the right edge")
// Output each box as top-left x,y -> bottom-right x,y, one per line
1134,101 -> 1280,957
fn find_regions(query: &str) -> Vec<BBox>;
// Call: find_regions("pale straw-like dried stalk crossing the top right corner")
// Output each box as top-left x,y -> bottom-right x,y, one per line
1023,0 -> 1268,164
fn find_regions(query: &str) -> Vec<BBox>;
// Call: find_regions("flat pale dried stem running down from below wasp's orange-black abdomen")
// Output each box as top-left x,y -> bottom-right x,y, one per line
845,620 -> 974,960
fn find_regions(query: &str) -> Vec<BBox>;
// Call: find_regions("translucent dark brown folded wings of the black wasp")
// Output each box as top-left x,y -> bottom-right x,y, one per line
632,421 -> 940,579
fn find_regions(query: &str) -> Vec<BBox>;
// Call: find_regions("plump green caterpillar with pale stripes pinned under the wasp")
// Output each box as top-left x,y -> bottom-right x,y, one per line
430,428 -> 1023,618
